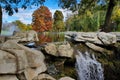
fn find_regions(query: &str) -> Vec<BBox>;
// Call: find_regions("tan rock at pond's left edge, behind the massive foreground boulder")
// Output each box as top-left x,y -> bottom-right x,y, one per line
9,30 -> 39,42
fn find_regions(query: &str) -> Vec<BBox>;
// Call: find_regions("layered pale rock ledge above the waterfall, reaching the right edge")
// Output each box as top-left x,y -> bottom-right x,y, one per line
65,32 -> 120,53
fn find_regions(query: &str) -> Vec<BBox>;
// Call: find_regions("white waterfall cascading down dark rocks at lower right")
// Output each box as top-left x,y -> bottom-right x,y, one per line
76,51 -> 104,80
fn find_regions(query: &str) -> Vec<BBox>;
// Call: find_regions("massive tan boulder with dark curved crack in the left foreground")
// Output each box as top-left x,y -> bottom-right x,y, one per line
0,40 -> 47,80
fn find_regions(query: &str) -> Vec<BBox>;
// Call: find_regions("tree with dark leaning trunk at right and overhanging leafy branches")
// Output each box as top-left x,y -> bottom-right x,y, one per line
59,0 -> 119,32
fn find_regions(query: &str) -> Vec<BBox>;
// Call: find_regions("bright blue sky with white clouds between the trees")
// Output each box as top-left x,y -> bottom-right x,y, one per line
3,0 -> 71,24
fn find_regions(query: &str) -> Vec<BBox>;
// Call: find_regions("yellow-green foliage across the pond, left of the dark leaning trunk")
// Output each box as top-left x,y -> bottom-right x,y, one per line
66,10 -> 105,32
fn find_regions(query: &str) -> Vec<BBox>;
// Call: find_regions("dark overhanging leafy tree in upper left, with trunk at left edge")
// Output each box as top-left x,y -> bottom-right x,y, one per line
0,0 -> 45,33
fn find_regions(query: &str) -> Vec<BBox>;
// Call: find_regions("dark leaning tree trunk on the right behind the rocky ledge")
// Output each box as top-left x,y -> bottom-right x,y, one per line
102,0 -> 115,32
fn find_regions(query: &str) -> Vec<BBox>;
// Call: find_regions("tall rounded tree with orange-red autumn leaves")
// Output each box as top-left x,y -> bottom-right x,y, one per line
32,6 -> 52,32
